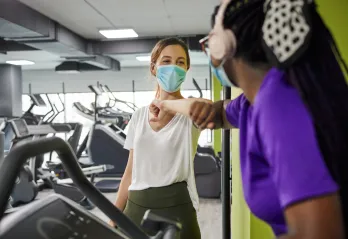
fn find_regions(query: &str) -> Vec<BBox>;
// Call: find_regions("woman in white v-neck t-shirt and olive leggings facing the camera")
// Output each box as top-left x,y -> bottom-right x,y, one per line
111,38 -> 200,239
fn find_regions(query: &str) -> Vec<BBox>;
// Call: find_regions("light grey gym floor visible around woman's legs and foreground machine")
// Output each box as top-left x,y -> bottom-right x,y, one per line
38,190 -> 222,239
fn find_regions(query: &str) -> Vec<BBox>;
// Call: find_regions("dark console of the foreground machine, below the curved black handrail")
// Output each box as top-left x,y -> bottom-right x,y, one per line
0,194 -> 128,239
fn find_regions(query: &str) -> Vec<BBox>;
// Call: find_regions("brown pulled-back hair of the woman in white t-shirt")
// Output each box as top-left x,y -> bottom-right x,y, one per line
150,37 -> 191,99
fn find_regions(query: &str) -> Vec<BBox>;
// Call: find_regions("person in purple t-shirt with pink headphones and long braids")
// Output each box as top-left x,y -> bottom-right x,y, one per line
151,0 -> 348,239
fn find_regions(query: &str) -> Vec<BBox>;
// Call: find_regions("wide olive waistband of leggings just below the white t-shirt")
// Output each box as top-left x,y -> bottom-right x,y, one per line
128,182 -> 192,208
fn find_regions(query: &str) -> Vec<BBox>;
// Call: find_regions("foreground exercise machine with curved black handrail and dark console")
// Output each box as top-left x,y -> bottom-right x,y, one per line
0,137 -> 181,239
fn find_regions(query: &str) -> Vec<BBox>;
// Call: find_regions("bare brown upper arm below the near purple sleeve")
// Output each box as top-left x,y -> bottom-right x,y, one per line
279,194 -> 345,239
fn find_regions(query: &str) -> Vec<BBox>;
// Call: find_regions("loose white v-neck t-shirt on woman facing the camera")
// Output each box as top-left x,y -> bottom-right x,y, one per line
124,106 -> 200,210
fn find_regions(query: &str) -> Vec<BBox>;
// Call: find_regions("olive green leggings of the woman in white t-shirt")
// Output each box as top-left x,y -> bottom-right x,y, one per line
124,182 -> 201,239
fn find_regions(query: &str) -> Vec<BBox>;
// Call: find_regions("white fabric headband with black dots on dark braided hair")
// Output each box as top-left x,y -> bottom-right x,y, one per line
262,0 -> 313,68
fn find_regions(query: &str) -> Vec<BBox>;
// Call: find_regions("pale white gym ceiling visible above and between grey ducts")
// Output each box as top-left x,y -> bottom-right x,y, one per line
0,0 -> 220,70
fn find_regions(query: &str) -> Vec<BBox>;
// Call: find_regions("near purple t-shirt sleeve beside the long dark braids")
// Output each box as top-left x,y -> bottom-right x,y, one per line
258,90 -> 338,208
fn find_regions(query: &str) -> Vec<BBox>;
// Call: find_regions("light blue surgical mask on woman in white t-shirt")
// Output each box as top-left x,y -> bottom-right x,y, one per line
156,65 -> 186,93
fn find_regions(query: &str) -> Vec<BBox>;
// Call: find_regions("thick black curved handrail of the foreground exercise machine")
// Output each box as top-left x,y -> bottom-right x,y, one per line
0,137 -> 149,239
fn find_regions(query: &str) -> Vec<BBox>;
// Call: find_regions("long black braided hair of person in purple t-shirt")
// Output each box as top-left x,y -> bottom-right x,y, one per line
212,0 -> 348,228
